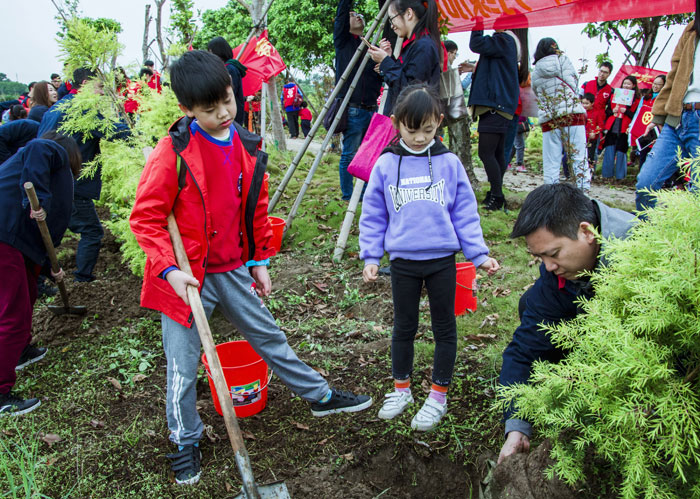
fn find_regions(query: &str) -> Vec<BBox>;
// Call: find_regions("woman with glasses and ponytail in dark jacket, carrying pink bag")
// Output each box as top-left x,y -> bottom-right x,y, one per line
367,0 -> 440,116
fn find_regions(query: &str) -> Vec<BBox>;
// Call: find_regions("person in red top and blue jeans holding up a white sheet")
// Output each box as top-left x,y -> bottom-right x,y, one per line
602,76 -> 639,180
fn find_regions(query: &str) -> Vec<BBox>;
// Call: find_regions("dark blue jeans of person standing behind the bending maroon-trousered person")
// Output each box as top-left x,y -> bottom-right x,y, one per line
68,198 -> 105,282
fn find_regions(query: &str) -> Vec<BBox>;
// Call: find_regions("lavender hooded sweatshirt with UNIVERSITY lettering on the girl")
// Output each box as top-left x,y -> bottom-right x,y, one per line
360,141 -> 489,267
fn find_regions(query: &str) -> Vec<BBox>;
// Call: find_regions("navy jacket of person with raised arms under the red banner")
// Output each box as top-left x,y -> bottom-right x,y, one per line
468,31 -> 520,114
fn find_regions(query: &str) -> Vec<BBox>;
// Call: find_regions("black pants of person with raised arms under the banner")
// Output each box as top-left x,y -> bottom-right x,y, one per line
477,111 -> 511,197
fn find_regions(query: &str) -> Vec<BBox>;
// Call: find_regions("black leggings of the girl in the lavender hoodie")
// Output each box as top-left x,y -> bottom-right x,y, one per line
391,255 -> 457,386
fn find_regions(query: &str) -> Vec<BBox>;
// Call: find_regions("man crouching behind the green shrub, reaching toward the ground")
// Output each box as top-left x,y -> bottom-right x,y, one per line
498,184 -> 635,463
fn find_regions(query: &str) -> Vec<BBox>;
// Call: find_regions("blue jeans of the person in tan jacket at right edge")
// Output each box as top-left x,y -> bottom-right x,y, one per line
636,110 -> 700,211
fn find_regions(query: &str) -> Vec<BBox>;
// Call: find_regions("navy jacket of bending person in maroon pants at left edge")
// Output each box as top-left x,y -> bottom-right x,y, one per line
0,139 -> 73,265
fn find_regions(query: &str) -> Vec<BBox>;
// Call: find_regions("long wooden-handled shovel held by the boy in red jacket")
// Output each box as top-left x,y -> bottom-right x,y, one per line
168,213 -> 290,499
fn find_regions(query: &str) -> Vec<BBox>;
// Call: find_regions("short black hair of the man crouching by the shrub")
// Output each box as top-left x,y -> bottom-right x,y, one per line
510,184 -> 598,239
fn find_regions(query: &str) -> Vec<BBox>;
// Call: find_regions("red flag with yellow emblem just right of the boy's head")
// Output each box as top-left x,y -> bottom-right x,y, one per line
233,30 -> 287,96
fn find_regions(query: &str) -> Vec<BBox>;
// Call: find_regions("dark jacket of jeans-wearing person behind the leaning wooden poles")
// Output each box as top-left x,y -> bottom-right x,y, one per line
333,0 -> 382,107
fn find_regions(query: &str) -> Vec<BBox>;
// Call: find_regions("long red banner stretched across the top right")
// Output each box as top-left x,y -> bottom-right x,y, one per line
436,0 -> 695,33
